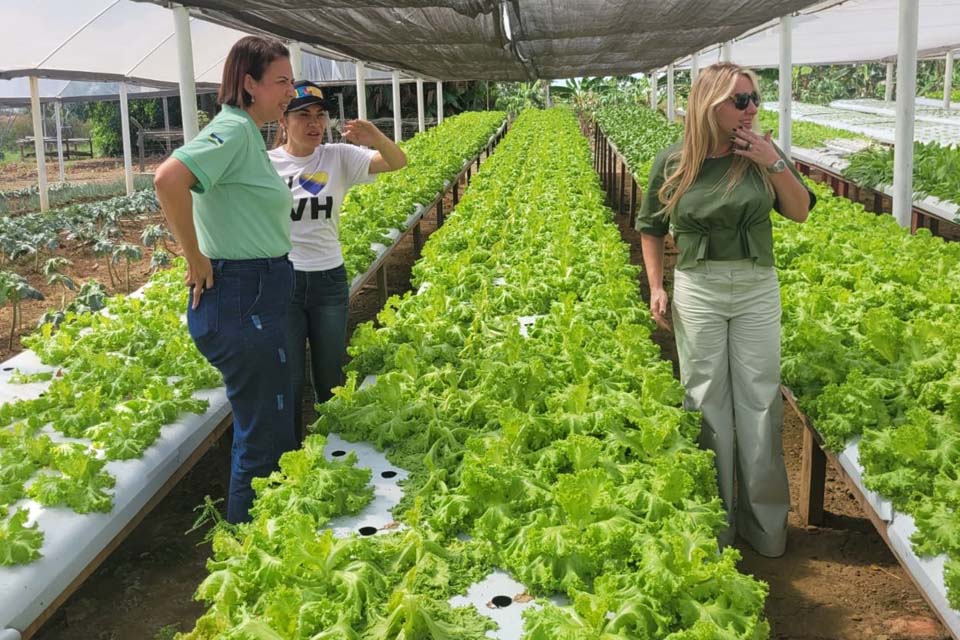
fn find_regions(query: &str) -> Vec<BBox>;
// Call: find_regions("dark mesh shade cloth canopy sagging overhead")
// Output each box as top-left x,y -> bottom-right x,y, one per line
125,0 -> 813,80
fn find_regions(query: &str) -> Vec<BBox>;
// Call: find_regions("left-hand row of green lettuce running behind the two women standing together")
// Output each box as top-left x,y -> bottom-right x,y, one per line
0,112 -> 505,566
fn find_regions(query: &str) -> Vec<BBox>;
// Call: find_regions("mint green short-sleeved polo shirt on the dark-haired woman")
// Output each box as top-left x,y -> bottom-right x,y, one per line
173,105 -> 293,260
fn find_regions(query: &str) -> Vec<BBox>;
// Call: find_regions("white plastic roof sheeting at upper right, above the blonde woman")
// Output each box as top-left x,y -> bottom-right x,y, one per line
677,0 -> 960,69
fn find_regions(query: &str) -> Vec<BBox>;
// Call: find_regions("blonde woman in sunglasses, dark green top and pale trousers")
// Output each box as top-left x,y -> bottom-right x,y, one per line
637,63 -> 816,557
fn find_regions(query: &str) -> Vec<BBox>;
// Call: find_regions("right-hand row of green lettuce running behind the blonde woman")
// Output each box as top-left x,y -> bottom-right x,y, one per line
600,102 -> 960,608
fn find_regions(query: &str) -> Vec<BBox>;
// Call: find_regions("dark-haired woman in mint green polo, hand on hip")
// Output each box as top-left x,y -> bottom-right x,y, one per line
154,36 -> 297,523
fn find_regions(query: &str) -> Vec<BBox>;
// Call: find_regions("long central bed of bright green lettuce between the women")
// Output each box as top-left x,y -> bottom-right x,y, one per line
176,110 -> 769,640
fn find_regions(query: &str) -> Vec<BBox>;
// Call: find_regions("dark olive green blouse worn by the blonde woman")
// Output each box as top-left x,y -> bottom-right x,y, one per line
636,144 -> 816,269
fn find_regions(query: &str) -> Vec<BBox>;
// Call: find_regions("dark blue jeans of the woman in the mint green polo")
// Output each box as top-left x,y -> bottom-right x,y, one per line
187,256 -> 297,523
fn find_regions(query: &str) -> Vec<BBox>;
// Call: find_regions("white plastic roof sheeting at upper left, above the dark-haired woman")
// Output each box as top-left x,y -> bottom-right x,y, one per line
0,0 -> 408,90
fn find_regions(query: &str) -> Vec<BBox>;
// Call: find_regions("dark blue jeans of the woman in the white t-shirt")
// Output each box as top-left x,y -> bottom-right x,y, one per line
287,265 -> 350,441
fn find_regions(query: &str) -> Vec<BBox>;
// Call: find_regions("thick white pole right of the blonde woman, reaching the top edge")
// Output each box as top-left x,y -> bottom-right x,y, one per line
893,0 -> 920,228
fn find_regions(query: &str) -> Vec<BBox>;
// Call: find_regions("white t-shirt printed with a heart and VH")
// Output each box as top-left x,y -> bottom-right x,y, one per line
269,144 -> 377,271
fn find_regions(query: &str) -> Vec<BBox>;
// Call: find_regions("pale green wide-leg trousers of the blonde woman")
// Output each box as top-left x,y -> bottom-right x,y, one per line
673,260 -> 790,557
